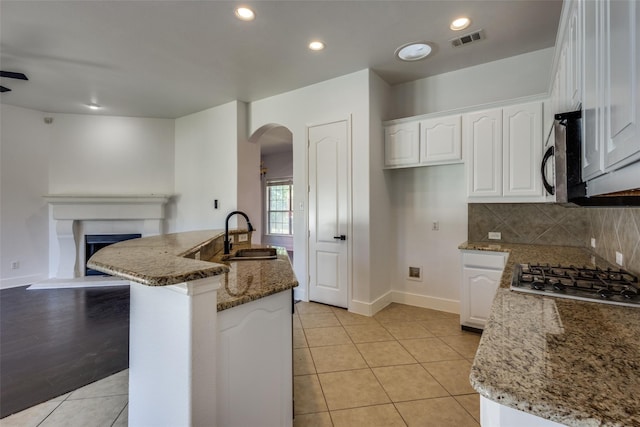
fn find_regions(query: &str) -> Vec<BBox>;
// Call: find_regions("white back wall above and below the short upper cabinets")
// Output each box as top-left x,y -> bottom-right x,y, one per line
384,48 -> 553,312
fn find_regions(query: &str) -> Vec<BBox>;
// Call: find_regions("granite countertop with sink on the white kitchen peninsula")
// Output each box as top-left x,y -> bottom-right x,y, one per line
87,230 -> 298,311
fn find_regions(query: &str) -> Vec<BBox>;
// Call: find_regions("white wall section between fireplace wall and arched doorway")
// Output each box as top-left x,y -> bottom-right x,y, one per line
172,101 -> 240,232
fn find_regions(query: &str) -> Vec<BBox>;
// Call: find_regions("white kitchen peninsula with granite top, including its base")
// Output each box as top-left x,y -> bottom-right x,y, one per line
87,230 -> 298,426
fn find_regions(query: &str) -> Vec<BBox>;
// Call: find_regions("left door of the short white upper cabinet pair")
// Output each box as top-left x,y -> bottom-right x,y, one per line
384,121 -> 420,166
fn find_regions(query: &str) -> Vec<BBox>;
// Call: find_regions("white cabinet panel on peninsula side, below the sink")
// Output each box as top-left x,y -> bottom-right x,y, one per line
217,290 -> 293,427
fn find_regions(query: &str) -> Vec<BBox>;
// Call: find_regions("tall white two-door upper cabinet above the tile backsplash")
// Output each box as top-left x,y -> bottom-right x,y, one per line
463,102 -> 544,202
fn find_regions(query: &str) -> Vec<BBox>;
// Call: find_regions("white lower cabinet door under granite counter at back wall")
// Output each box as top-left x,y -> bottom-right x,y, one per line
460,267 -> 502,328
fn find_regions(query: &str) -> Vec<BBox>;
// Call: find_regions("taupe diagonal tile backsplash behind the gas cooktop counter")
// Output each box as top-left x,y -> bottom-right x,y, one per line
468,203 -> 640,273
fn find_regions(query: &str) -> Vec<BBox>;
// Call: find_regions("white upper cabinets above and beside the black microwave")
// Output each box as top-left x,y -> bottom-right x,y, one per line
552,0 -> 640,191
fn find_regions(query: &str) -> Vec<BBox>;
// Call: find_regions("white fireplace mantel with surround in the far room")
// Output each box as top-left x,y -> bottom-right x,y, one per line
43,194 -> 172,279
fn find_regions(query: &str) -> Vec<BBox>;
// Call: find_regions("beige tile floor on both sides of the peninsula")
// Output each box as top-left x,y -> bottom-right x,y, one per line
0,302 -> 479,427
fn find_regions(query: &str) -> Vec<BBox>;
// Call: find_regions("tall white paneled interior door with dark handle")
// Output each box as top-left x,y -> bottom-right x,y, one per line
308,120 -> 351,308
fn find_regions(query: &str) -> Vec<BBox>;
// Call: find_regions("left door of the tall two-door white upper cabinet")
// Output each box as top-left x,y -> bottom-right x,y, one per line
463,108 -> 502,197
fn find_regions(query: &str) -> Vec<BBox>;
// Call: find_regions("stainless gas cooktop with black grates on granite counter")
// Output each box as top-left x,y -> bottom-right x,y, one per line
511,264 -> 640,307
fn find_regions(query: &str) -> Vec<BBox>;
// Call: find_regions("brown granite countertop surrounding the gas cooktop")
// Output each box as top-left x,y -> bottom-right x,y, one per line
460,242 -> 640,426
